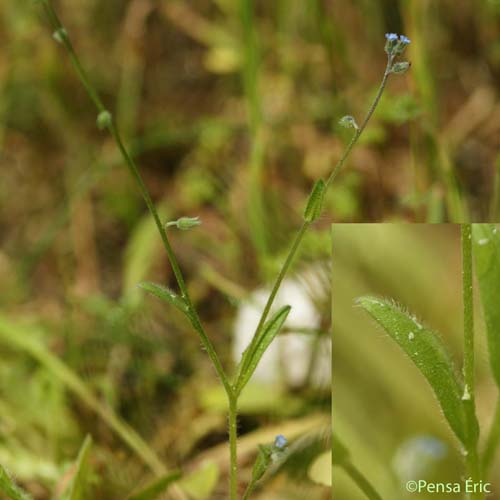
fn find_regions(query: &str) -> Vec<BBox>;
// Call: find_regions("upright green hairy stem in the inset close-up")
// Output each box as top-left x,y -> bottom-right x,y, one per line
461,224 -> 484,499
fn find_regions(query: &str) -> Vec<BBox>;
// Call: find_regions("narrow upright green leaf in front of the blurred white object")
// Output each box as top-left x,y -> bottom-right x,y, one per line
236,306 -> 291,393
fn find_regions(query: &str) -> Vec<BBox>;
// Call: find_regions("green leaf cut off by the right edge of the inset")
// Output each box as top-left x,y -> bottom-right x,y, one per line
472,224 -> 500,387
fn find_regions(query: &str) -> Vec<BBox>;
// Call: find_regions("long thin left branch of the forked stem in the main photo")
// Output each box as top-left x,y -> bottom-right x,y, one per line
38,0 -> 232,394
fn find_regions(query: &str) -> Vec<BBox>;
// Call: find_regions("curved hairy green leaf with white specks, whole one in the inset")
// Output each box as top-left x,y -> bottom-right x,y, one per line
358,297 -> 466,443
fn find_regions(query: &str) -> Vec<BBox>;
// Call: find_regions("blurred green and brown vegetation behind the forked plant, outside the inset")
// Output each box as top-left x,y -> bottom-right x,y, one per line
0,0 -> 500,500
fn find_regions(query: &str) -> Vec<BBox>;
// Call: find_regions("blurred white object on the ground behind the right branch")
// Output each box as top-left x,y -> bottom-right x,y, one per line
233,268 -> 331,387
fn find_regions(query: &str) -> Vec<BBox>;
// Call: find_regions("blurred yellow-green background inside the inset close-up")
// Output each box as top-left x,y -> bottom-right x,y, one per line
332,224 -> 500,500
